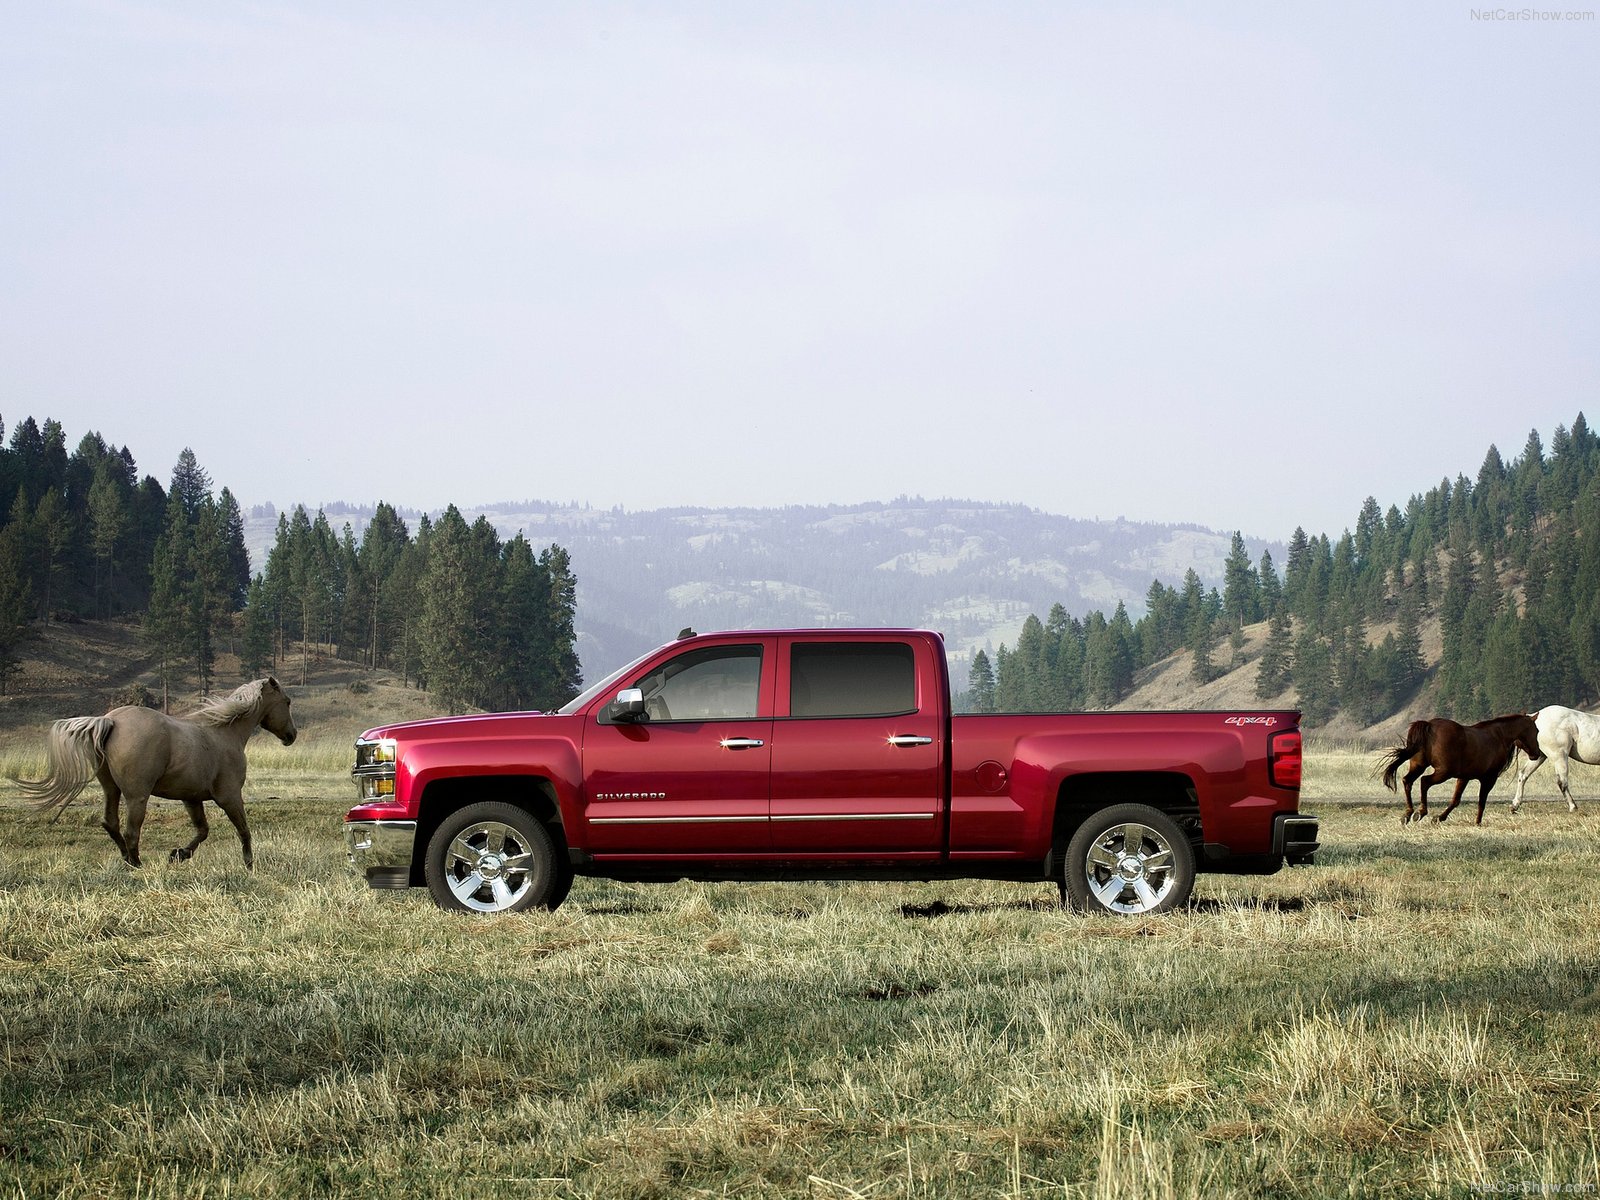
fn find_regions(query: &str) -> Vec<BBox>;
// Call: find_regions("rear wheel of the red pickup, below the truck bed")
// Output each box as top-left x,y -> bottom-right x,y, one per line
1062,805 -> 1195,917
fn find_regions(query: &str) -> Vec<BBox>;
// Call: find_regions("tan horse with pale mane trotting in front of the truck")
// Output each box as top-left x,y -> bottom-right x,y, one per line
13,678 -> 296,867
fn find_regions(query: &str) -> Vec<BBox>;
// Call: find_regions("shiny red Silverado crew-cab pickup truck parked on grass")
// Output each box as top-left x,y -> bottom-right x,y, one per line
344,629 -> 1317,914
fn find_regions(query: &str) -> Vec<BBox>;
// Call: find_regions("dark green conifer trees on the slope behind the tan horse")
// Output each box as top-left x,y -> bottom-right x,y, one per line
0,418 -> 579,709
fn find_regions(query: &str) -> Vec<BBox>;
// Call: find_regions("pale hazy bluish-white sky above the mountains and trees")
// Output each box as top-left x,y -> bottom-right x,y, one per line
0,0 -> 1600,538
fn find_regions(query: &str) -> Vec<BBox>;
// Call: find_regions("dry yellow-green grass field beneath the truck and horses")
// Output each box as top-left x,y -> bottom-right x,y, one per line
0,733 -> 1600,1198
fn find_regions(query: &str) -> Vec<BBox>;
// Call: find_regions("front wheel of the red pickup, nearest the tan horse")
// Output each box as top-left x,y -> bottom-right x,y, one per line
422,800 -> 571,914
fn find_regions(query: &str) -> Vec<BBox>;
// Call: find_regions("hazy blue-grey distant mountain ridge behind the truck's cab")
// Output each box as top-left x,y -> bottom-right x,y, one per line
245,496 -> 1285,685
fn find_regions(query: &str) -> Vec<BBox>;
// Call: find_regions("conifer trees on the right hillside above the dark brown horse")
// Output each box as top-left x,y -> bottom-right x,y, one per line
965,413 -> 1600,726
